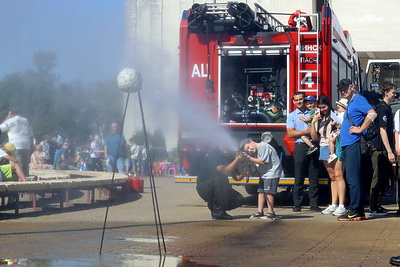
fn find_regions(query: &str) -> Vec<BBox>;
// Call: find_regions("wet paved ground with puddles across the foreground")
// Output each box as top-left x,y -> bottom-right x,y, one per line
0,177 -> 400,266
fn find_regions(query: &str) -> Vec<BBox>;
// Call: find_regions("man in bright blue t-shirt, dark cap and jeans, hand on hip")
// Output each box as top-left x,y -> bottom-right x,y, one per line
337,79 -> 376,221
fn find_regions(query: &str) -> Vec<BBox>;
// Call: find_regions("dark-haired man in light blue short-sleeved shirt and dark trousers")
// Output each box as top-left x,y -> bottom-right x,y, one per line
286,92 -> 321,212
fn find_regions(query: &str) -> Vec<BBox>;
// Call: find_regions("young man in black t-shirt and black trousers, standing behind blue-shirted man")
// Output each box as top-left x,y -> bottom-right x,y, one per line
369,82 -> 396,216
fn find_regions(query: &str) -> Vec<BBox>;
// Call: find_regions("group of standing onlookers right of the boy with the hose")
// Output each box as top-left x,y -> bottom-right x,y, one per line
287,79 -> 400,221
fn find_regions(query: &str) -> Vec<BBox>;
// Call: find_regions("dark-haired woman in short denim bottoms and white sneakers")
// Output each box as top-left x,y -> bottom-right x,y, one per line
311,95 -> 346,216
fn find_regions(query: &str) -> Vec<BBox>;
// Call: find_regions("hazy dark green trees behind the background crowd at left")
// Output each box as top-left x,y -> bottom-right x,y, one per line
0,52 -> 123,146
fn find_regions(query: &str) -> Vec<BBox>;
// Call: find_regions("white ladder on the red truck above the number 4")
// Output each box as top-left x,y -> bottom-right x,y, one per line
297,14 -> 320,98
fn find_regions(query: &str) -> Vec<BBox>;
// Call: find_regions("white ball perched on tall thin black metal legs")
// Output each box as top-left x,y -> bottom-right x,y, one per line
100,68 -> 167,256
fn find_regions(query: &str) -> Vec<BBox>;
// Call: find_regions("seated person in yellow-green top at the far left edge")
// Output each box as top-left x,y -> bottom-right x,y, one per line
0,143 -> 26,182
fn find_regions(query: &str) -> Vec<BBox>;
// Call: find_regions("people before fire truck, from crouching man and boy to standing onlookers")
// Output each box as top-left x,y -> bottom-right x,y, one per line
197,79 -> 400,224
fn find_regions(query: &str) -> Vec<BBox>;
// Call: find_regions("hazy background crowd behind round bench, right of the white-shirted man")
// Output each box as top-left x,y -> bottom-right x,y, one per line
47,122 -> 149,176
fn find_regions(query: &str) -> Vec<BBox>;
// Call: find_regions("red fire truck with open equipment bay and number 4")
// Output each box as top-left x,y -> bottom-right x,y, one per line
178,2 -> 360,184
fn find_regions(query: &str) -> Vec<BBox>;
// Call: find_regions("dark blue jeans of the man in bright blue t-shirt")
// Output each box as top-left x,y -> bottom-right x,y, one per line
342,142 -> 364,214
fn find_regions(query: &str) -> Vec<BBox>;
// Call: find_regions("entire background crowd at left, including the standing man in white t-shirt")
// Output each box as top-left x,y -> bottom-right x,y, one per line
0,115 -> 149,181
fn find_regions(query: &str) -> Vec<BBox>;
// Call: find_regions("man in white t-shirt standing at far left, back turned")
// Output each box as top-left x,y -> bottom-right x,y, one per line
0,107 -> 33,176
